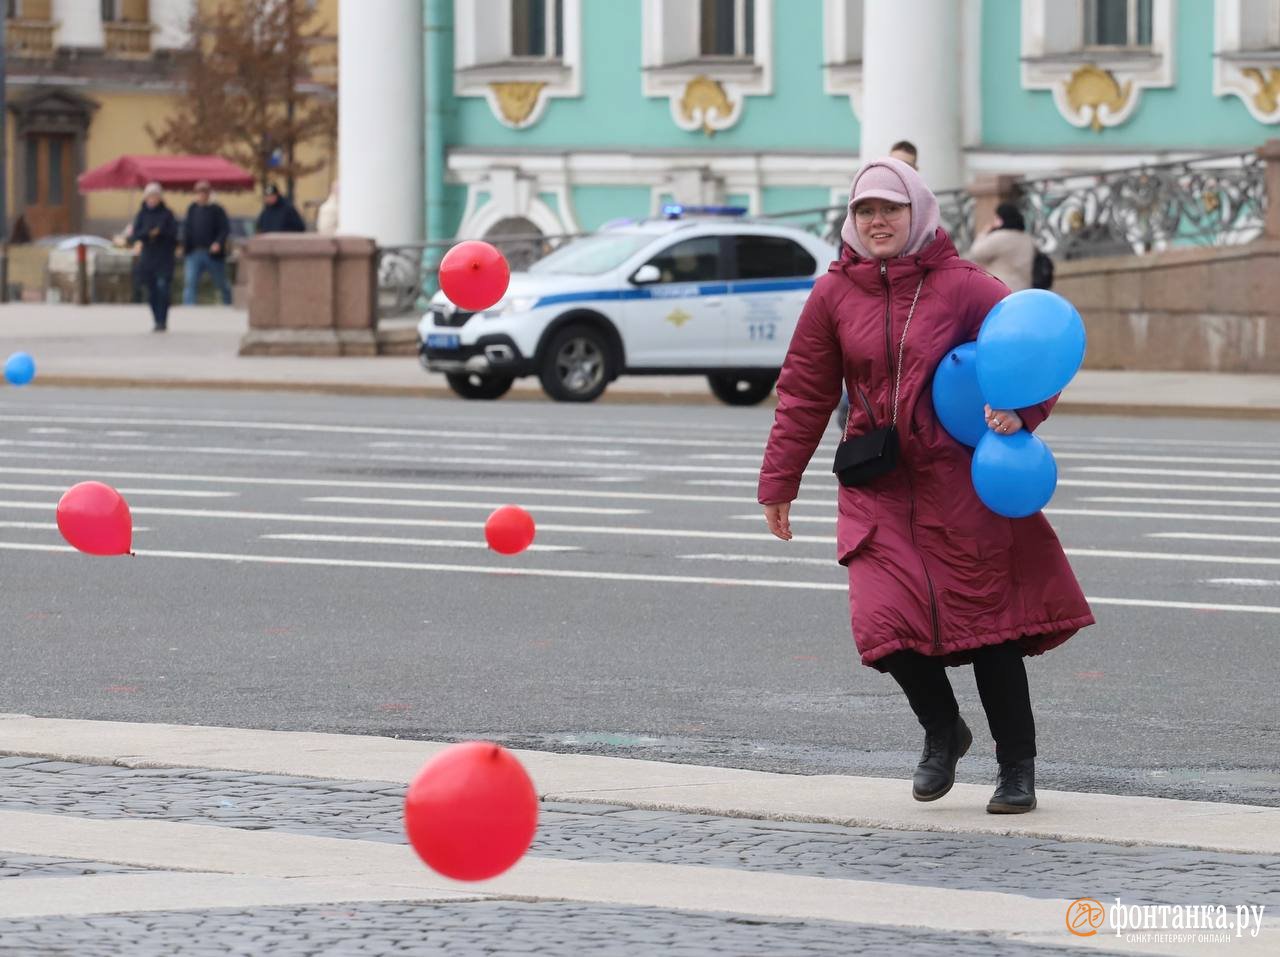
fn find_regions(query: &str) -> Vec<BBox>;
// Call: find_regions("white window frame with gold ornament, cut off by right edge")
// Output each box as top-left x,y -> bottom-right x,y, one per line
1213,0 -> 1280,124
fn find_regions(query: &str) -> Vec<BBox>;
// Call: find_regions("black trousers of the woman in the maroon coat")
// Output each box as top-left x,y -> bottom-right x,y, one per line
882,641 -> 1036,764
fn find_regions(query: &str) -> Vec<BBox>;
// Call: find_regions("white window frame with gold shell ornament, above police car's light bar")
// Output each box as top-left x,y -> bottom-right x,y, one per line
641,0 -> 773,136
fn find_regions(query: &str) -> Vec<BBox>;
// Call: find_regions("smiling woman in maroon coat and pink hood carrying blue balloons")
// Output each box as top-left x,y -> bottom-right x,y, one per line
758,157 -> 1093,814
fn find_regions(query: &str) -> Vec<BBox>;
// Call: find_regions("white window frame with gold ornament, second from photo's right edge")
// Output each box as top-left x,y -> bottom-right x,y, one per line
1021,0 -> 1176,133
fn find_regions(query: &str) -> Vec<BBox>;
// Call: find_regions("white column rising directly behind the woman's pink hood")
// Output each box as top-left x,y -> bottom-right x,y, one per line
859,0 -> 965,191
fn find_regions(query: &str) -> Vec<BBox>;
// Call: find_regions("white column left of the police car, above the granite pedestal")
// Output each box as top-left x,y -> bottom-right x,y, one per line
338,0 -> 425,246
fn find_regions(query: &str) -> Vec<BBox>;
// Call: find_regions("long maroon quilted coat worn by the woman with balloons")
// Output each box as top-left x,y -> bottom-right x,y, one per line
759,229 -> 1093,672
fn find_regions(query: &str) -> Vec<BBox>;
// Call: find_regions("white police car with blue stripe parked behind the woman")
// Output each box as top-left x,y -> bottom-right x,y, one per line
419,207 -> 837,406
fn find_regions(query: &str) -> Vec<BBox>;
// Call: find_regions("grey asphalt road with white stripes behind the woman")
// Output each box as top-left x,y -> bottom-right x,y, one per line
0,388 -> 1280,805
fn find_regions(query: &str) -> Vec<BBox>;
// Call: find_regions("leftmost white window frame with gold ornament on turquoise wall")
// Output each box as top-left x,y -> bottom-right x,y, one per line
453,0 -> 582,129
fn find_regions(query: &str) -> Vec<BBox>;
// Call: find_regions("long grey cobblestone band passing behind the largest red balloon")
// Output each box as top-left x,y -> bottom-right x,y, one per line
0,757 -> 1280,911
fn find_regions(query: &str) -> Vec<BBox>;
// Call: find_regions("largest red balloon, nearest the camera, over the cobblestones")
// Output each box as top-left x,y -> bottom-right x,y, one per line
404,741 -> 538,880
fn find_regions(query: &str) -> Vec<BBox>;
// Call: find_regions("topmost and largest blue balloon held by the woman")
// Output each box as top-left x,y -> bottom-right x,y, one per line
978,289 -> 1084,409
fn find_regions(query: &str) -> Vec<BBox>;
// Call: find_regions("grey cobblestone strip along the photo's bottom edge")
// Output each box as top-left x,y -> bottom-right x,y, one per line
0,903 -> 1131,957
